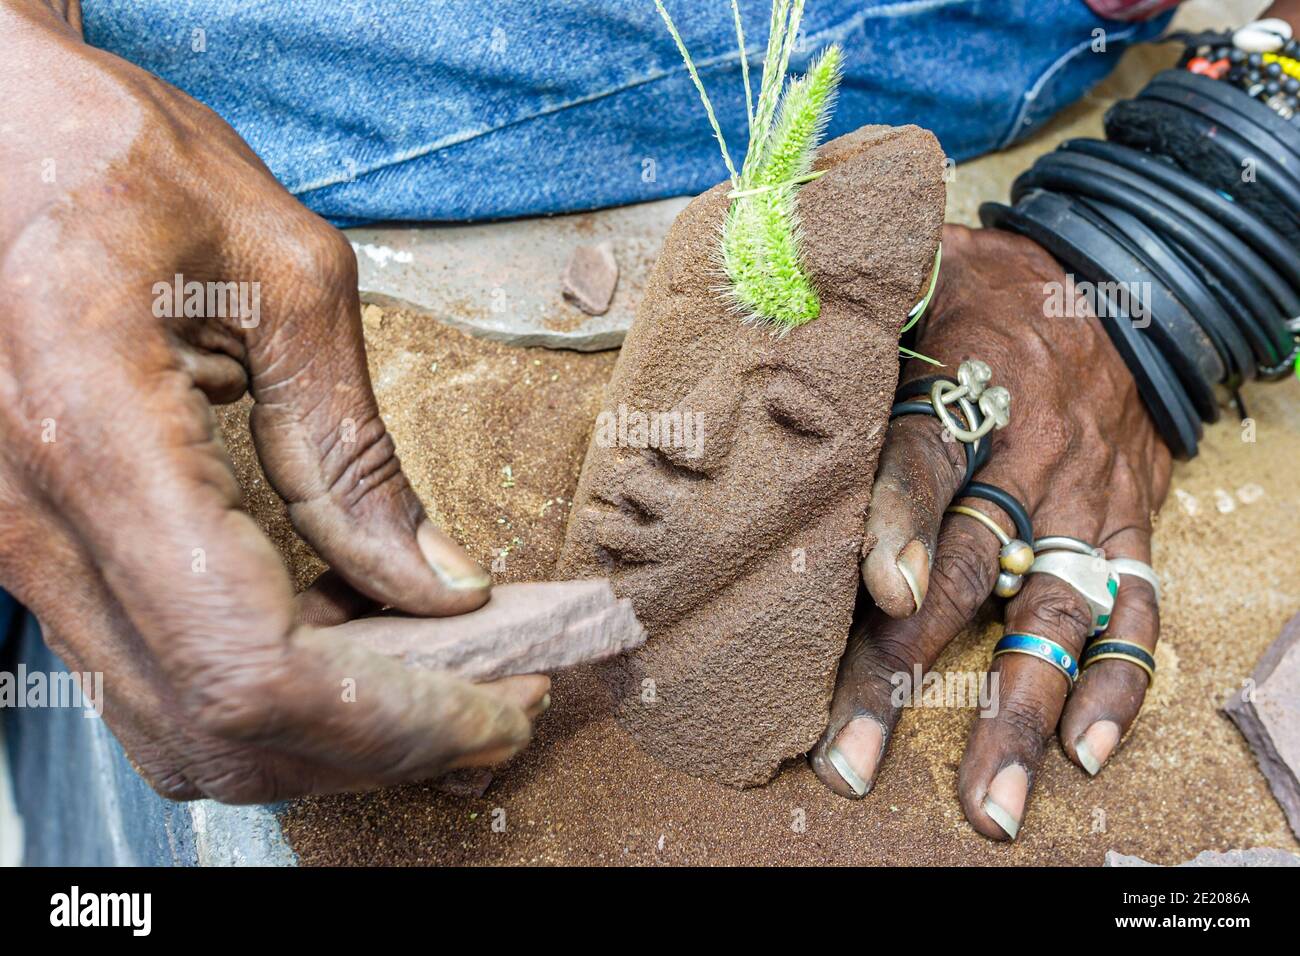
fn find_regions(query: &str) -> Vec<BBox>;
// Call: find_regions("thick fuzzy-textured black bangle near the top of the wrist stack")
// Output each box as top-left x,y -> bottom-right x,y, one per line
1104,100 -> 1300,246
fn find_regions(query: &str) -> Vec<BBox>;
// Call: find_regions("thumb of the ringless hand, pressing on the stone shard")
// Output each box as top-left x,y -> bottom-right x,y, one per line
246,220 -> 491,615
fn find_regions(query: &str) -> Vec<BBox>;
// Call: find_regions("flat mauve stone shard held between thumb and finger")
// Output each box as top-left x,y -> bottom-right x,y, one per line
351,579 -> 646,682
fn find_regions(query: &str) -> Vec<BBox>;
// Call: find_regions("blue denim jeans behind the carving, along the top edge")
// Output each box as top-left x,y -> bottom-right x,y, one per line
82,0 -> 1167,224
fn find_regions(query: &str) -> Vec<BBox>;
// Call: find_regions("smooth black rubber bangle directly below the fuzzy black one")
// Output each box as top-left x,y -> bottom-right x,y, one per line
1061,139 -> 1300,306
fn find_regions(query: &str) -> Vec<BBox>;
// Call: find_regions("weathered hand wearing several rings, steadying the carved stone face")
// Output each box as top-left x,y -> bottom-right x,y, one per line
811,226 -> 1171,839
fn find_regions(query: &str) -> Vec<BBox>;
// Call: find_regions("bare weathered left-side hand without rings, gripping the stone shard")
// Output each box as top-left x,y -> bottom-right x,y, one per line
0,0 -> 549,803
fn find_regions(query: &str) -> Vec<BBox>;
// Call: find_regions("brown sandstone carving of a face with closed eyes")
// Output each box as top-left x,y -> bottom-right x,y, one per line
560,126 -> 944,787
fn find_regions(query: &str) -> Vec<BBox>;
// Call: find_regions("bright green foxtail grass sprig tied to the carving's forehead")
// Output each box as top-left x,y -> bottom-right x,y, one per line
655,0 -> 842,332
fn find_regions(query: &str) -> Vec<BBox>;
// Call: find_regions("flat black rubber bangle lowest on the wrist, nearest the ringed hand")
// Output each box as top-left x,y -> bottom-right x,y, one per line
980,191 -> 1201,459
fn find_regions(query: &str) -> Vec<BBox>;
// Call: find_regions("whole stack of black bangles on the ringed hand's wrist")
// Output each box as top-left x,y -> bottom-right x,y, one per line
971,35 -> 1300,460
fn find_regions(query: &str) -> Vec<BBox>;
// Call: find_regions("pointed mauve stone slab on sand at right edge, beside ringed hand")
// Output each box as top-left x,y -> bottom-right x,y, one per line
1223,614 -> 1300,836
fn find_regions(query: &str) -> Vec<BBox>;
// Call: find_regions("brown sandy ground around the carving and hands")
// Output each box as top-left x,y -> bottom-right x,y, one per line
215,18 -> 1300,865
